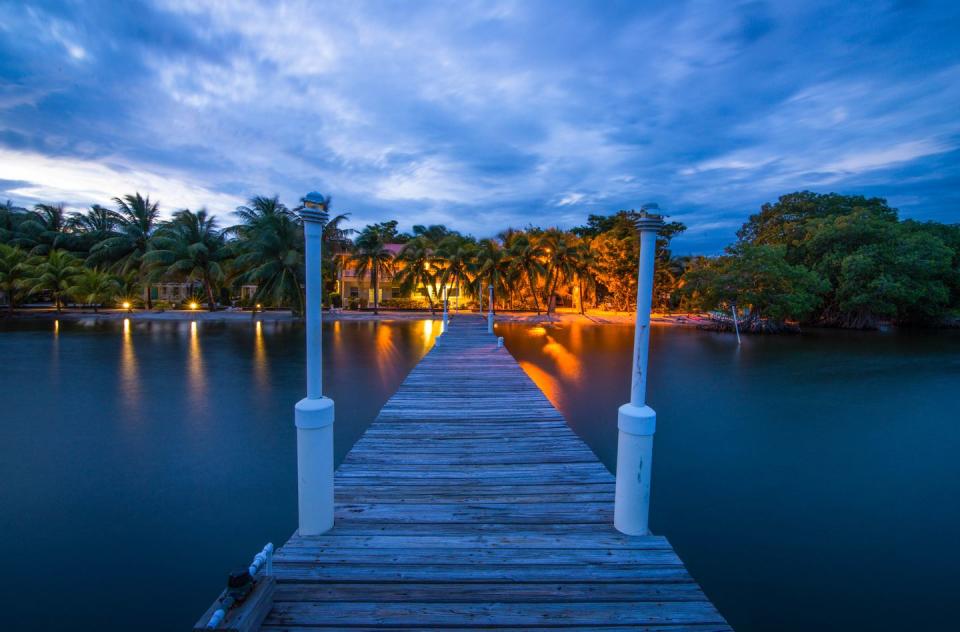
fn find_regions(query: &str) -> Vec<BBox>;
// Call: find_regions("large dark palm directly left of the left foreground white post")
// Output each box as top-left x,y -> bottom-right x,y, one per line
231,196 -> 304,314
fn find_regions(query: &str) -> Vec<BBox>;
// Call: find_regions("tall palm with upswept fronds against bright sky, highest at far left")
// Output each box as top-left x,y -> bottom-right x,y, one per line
87,192 -> 160,309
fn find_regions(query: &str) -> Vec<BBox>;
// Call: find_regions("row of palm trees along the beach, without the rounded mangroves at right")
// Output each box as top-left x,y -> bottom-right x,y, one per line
0,193 -> 684,313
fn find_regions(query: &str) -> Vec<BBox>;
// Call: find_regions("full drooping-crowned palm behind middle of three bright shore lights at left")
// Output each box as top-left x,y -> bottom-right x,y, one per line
143,209 -> 225,312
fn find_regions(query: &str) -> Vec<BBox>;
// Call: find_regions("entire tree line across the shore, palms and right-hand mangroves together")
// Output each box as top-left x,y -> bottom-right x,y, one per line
0,192 -> 960,331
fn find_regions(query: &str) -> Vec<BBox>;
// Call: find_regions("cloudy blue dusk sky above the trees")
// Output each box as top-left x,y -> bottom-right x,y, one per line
0,0 -> 960,252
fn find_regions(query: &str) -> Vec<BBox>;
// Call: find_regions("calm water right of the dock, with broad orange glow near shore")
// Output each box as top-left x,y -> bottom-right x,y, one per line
499,324 -> 960,631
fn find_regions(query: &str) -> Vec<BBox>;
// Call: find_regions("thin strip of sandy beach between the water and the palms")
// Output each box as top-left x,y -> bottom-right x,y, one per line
0,309 -> 709,327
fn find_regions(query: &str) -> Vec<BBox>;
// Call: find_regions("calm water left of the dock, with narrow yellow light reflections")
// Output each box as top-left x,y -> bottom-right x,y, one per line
0,320 -> 440,632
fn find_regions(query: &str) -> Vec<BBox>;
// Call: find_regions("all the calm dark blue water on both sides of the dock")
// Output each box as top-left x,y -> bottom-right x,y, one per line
0,321 -> 960,631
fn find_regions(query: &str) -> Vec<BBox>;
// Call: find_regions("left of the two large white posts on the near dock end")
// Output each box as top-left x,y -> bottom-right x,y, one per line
294,192 -> 333,535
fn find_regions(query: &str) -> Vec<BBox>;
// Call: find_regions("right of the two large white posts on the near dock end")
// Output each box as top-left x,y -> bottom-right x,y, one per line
613,210 -> 664,535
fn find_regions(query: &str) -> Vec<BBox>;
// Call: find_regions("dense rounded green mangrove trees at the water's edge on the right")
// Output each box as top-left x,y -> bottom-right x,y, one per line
678,191 -> 960,331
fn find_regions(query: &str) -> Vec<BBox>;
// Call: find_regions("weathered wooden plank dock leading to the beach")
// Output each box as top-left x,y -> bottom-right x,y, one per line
255,316 -> 730,632
